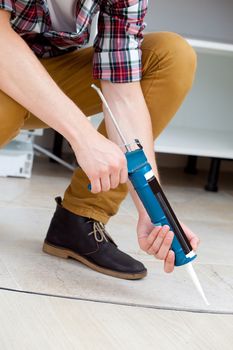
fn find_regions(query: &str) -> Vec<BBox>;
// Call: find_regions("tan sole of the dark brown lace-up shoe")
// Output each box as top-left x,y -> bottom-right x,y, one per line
43,242 -> 147,280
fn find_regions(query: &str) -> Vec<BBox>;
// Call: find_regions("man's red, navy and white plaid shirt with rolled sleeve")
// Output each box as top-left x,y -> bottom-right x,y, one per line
0,0 -> 147,83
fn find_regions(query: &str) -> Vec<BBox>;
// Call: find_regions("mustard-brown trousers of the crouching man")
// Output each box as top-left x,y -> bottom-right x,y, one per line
0,32 -> 196,223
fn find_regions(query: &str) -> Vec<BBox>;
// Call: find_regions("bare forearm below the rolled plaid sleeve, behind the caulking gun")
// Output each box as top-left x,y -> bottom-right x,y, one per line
101,81 -> 159,216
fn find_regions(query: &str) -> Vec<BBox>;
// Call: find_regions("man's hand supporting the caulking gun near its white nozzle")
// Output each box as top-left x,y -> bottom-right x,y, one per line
137,215 -> 200,273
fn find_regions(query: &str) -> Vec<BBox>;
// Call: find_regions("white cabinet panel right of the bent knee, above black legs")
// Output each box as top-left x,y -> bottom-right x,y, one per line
155,41 -> 233,159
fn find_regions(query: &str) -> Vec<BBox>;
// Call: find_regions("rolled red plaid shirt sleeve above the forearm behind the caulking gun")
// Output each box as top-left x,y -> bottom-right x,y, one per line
93,0 -> 148,83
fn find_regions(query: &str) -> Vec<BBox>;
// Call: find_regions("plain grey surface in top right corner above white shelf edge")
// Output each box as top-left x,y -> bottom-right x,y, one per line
146,0 -> 233,43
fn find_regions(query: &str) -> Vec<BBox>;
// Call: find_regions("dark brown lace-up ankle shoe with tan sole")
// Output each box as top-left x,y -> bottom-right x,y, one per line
43,197 -> 147,280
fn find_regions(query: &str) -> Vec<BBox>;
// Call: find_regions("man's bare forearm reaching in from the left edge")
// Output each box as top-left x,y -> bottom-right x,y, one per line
0,13 -> 91,143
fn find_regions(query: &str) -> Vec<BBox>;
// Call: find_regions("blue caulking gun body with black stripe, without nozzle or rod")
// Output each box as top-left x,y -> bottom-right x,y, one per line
125,145 -> 196,266
